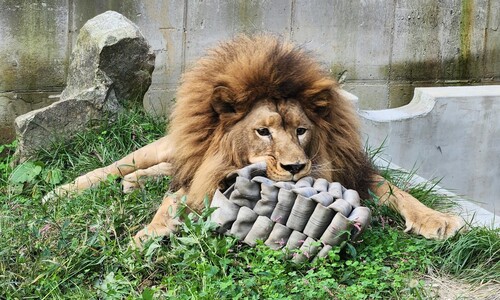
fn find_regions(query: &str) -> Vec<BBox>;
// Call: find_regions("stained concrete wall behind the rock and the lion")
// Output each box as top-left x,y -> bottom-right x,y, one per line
0,0 -> 500,142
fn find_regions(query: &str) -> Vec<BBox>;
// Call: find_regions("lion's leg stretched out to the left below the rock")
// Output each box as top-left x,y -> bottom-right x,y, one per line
44,136 -> 175,200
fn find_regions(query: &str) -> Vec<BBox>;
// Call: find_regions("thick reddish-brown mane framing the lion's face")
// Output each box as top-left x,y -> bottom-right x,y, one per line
170,35 -> 373,202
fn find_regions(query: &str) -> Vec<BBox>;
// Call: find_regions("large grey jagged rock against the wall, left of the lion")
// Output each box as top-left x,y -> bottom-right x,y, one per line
15,11 -> 155,161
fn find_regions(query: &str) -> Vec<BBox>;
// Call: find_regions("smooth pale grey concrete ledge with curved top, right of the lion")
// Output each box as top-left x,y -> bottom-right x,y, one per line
359,85 -> 500,215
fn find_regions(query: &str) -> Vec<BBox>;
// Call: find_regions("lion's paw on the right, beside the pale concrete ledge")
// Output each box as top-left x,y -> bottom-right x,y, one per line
405,209 -> 465,240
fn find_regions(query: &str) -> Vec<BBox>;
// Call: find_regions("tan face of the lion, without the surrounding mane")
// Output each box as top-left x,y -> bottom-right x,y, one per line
228,99 -> 315,181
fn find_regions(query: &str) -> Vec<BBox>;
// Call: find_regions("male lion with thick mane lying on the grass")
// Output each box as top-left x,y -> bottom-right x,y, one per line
47,35 -> 462,243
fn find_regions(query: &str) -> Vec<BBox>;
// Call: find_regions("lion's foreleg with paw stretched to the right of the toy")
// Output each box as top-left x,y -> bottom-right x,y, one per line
372,175 -> 464,239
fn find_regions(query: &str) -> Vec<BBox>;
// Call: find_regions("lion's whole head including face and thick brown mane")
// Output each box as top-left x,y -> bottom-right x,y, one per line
169,36 -> 372,205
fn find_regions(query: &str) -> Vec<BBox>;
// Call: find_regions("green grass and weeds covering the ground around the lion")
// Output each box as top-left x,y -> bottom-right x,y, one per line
0,111 -> 500,299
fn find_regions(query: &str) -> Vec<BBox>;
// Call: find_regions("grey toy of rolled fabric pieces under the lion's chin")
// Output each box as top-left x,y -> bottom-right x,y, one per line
210,163 -> 371,262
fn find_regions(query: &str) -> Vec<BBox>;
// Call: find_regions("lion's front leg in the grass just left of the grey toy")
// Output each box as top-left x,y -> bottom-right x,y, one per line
134,189 -> 184,247
